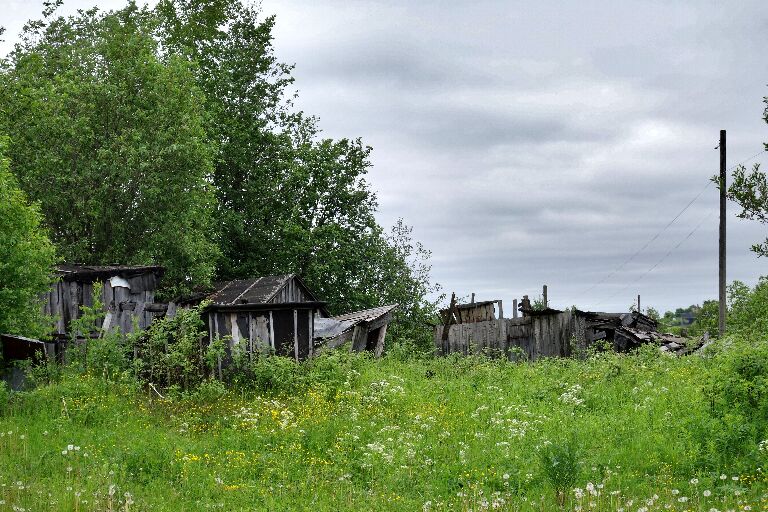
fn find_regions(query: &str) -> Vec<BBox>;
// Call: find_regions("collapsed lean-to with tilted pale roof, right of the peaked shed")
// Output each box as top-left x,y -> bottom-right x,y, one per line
315,304 -> 397,357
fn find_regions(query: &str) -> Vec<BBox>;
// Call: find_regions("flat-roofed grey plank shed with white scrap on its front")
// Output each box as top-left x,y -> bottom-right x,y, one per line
43,264 -> 165,340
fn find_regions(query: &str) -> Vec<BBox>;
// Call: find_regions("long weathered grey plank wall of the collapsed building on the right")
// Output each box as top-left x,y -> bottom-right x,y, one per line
435,311 -> 586,360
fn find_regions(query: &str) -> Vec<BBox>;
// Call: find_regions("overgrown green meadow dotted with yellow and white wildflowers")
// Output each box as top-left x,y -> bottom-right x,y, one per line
0,340 -> 768,512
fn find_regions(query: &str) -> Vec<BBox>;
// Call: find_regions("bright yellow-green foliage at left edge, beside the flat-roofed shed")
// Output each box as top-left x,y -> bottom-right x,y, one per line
0,137 -> 55,335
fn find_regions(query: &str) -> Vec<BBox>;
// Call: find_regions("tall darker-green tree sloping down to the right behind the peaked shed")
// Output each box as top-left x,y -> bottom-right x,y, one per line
157,0 -> 435,344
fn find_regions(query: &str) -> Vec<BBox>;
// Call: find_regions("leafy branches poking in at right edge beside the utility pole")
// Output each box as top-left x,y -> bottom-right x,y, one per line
728,96 -> 768,256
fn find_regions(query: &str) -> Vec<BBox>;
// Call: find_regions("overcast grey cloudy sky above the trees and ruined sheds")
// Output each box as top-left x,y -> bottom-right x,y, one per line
0,0 -> 768,311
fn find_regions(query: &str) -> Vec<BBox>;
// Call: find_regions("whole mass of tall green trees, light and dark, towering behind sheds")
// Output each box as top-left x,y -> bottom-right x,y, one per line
0,0 -> 435,339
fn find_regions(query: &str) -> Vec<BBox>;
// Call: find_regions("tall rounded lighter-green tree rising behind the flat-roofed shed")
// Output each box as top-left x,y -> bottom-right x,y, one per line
0,3 -> 217,296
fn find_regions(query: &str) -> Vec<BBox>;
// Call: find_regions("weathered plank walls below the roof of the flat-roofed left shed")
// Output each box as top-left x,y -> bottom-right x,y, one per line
43,274 -> 162,337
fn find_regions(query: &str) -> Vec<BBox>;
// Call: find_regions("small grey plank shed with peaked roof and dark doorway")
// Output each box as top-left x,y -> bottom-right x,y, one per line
184,274 -> 328,360
